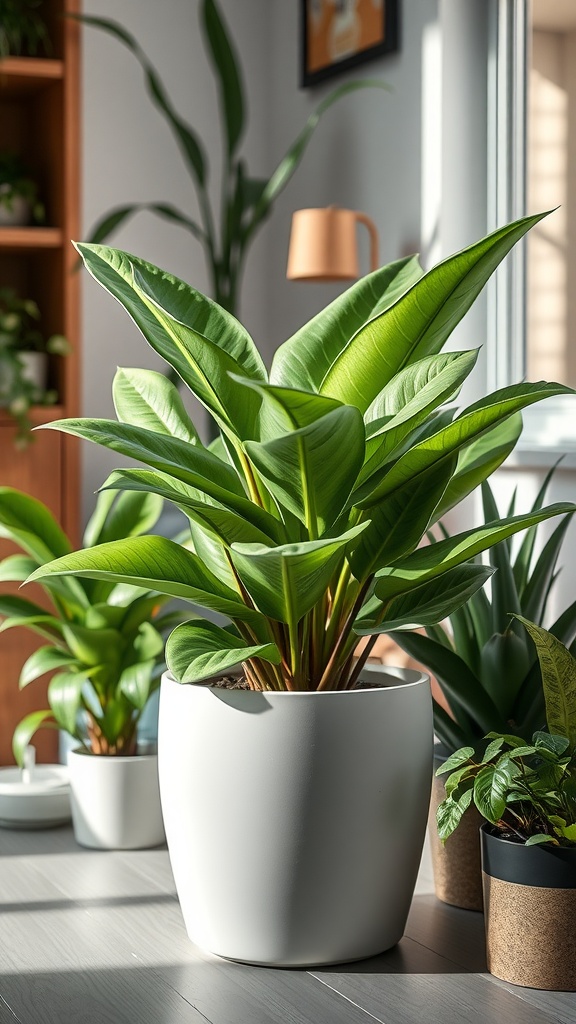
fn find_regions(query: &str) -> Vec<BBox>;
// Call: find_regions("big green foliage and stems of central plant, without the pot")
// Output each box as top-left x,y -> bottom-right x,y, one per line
23,216 -> 574,690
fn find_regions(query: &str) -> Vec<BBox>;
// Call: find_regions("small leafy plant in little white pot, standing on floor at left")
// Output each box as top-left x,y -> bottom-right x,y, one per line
0,487 -> 182,849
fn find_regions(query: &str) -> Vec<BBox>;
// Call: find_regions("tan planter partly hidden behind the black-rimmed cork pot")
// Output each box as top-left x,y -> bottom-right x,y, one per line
428,757 -> 484,910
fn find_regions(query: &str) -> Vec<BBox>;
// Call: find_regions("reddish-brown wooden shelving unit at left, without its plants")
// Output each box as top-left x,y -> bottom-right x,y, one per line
0,0 -> 80,764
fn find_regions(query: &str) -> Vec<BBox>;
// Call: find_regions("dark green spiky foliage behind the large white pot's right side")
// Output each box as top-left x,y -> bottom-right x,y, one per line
391,468 -> 576,751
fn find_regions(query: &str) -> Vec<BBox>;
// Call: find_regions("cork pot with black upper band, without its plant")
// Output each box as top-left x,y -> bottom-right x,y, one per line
481,825 -> 576,992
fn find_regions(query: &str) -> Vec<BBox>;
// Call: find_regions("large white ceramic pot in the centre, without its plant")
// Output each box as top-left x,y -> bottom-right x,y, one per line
159,667 -> 433,967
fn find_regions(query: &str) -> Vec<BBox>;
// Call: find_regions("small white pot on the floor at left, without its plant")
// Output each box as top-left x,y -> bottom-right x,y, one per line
68,750 -> 164,850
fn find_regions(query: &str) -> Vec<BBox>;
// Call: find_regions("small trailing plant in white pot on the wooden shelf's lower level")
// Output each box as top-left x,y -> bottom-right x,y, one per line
0,288 -> 71,447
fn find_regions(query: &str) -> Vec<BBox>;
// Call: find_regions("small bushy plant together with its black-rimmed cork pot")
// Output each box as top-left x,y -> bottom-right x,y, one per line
438,618 -> 576,991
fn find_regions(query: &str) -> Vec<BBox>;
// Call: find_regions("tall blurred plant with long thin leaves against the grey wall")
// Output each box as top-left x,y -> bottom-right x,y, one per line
72,0 -> 388,313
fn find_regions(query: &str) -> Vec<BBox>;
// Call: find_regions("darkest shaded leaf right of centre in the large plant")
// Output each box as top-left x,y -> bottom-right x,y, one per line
349,461 -> 455,581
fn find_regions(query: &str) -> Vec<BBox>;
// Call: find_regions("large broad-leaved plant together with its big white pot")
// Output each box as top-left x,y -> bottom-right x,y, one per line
24,211 -> 573,965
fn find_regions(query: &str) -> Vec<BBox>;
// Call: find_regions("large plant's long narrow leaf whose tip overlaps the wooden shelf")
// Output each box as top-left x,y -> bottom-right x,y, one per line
42,419 -> 279,534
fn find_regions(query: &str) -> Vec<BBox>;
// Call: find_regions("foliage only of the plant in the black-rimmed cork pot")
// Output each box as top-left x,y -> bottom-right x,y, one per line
437,615 -> 576,847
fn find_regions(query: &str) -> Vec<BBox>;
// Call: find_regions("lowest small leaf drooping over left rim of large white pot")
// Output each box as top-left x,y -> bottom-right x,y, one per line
166,622 -> 280,683
